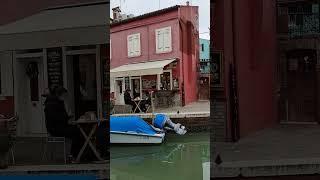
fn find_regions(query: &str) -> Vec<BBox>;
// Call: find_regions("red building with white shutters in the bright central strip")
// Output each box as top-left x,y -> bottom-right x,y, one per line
110,5 -> 199,106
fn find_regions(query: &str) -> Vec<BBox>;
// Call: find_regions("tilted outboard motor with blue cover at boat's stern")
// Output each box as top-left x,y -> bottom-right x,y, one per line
152,114 -> 187,135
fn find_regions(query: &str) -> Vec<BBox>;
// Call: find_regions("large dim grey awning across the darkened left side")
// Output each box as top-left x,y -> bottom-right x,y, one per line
0,1 -> 110,51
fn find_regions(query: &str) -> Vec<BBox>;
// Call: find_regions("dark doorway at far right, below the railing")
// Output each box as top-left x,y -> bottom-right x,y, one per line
287,50 -> 317,122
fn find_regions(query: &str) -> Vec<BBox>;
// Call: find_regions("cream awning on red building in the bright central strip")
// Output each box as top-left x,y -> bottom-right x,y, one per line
110,59 -> 176,77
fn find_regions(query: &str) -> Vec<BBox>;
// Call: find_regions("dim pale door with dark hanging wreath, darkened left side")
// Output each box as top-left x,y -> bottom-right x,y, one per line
15,57 -> 46,137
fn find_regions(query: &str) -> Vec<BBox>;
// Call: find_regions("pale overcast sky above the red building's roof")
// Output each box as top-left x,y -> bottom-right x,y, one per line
110,0 -> 210,39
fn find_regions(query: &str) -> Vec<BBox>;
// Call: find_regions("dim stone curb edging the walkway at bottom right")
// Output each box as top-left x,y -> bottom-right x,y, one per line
212,158 -> 320,178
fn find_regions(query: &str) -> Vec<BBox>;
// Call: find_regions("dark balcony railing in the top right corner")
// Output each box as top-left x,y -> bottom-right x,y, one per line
288,14 -> 320,38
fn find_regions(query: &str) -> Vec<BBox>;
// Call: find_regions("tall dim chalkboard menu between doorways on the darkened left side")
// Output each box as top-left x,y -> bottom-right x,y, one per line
47,48 -> 63,87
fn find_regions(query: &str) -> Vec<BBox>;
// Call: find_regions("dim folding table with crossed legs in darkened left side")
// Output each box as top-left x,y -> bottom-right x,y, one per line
72,119 -> 106,163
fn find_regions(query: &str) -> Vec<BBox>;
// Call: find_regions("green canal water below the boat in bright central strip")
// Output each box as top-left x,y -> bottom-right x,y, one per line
110,133 -> 210,180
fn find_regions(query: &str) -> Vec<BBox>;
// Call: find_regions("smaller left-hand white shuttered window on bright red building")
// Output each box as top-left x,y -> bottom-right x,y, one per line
127,33 -> 141,57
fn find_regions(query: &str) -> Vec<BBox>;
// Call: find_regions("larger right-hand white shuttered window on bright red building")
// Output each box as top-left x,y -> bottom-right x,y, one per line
156,26 -> 172,53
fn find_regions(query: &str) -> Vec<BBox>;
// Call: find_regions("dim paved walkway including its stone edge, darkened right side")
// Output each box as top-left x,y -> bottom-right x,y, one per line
212,125 -> 320,177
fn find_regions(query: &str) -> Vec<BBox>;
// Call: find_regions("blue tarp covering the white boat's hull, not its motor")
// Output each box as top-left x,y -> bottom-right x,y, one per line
110,116 -> 157,134
